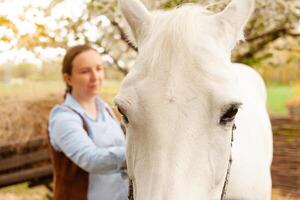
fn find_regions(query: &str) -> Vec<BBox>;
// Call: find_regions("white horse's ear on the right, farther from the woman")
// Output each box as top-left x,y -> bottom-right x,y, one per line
217,0 -> 255,50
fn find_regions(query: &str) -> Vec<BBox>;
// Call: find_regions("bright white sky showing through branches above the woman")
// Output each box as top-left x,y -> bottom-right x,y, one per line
0,0 -> 109,65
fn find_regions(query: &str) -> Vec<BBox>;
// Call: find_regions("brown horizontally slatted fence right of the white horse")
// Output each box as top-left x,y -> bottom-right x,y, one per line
272,118 -> 300,197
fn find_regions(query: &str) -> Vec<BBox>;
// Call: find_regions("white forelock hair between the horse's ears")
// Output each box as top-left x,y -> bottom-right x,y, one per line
142,5 -> 220,65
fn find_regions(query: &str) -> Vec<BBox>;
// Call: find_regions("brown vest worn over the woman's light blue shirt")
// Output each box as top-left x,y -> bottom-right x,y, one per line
48,105 -> 89,200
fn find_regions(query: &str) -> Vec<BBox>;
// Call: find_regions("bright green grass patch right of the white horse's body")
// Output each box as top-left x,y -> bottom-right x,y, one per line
267,85 -> 295,115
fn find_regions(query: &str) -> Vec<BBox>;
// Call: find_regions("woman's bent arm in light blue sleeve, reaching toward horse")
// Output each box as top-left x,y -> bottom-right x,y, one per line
49,108 -> 125,174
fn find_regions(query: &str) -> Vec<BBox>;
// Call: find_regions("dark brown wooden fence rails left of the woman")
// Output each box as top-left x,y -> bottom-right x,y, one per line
0,137 -> 52,187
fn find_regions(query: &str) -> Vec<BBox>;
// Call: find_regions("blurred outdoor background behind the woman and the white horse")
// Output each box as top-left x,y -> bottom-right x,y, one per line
0,0 -> 300,200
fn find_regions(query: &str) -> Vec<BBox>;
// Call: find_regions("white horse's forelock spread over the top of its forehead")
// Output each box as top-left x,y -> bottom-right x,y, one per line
138,5 -> 229,75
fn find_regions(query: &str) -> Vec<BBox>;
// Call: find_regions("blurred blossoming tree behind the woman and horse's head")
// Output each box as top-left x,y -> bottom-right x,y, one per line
0,0 -> 300,77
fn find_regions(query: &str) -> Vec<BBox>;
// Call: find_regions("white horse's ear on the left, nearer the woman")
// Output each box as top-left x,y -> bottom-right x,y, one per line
119,0 -> 151,45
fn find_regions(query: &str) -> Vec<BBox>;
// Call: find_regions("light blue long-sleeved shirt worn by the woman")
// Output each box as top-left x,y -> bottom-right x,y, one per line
49,94 -> 128,200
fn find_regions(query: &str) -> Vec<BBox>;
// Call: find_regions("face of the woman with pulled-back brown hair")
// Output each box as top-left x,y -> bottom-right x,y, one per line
64,50 -> 104,97
